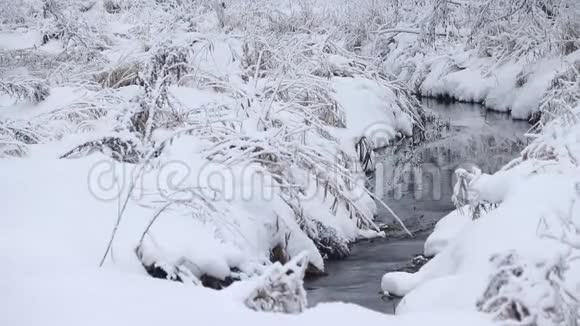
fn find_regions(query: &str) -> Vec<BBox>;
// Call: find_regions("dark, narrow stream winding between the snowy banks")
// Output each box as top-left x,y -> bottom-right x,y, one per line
306,100 -> 529,313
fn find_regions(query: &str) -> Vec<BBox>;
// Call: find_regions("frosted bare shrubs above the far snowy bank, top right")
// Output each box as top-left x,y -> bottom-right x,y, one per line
408,0 -> 580,61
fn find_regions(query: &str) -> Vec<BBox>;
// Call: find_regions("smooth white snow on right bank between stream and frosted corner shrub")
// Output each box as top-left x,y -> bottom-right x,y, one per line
381,128 -> 580,314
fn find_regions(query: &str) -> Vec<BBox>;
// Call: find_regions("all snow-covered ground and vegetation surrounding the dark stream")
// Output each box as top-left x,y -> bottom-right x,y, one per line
0,0 -> 580,325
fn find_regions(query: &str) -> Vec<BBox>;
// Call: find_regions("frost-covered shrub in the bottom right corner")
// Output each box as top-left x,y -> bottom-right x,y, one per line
477,183 -> 580,326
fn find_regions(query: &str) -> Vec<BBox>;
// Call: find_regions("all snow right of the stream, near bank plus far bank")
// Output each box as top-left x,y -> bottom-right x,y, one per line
381,14 -> 580,318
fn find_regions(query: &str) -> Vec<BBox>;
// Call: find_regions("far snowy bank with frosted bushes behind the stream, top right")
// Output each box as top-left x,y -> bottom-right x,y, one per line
374,0 -> 580,122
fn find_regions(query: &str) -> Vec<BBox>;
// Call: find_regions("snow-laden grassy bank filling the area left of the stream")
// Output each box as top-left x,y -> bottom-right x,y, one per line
0,1 -> 426,318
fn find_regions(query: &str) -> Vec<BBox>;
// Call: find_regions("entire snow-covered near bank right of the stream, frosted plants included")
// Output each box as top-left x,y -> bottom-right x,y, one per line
381,112 -> 580,324
